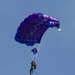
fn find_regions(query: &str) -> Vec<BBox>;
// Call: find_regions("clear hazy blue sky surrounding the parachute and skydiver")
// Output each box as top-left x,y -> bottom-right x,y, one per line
0,0 -> 75,75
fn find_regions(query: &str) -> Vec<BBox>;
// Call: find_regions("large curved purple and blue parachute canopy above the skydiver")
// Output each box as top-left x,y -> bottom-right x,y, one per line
15,13 -> 60,46
